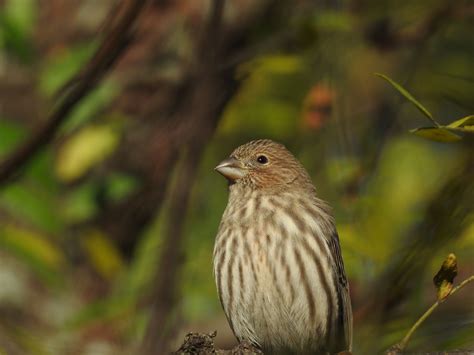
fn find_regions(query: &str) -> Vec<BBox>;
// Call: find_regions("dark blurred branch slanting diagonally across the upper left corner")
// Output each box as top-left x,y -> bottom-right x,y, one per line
0,0 -> 148,185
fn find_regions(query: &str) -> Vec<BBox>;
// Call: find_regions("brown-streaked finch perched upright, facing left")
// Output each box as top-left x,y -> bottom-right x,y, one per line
214,139 -> 352,354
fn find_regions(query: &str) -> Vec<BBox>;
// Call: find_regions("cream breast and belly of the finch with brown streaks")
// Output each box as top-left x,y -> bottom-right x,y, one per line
214,191 -> 333,348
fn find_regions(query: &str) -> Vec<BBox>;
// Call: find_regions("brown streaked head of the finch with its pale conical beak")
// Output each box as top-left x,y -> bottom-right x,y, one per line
215,139 -> 313,190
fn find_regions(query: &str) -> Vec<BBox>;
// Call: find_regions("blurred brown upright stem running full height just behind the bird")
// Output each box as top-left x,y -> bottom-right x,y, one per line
141,0 -> 229,354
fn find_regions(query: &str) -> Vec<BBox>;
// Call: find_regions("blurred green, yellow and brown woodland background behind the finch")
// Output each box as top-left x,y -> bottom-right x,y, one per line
0,0 -> 474,355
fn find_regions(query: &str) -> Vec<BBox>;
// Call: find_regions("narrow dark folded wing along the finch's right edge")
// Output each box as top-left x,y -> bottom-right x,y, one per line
327,231 -> 352,350
